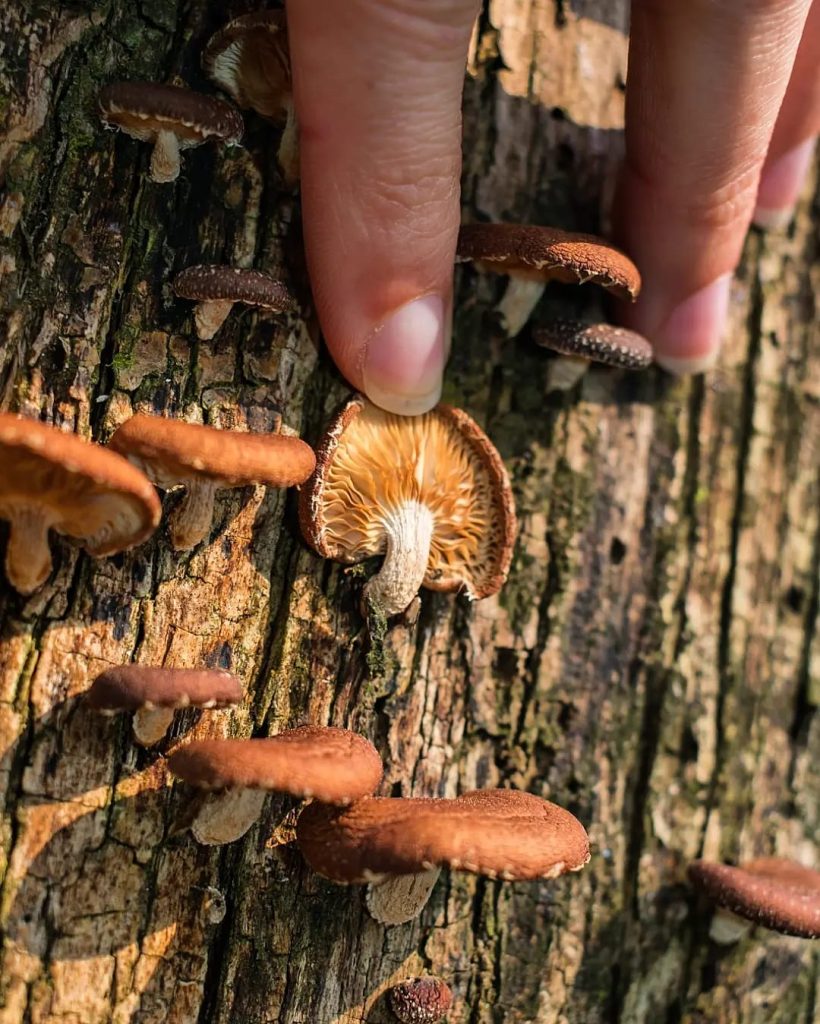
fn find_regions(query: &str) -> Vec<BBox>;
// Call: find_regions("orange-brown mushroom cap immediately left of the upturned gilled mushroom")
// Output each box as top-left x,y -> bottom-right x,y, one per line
109,413 -> 315,488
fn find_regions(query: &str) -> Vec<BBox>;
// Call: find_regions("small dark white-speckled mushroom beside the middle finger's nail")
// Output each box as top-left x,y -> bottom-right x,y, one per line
533,321 -> 652,391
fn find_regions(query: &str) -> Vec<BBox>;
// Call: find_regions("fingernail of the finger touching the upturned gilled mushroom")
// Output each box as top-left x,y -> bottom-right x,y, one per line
362,295 -> 449,416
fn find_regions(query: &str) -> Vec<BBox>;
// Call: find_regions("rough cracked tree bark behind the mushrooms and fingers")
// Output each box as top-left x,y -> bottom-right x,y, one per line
0,0 -> 820,1024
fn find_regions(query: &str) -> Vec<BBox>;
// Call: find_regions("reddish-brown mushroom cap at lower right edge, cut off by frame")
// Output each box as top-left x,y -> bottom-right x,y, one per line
689,857 -> 820,939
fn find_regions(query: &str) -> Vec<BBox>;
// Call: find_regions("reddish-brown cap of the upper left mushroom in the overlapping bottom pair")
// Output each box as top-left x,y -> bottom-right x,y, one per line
168,725 -> 384,804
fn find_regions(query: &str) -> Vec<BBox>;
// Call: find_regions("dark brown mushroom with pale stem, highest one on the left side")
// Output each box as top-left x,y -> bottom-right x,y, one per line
99,82 -> 245,182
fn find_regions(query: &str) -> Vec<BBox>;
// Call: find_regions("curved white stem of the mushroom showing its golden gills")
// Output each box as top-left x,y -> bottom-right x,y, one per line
364,502 -> 434,616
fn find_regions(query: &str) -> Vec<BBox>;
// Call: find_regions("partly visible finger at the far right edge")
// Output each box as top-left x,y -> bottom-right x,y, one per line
752,0 -> 820,228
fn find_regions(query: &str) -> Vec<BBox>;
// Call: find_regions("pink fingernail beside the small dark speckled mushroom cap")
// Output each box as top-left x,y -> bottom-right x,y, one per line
652,273 -> 732,374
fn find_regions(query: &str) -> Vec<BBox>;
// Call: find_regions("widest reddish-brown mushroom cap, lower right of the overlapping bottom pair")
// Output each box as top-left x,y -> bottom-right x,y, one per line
296,790 -> 590,883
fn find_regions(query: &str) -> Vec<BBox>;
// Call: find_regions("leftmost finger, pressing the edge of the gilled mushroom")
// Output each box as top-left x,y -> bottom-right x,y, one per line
288,0 -> 477,415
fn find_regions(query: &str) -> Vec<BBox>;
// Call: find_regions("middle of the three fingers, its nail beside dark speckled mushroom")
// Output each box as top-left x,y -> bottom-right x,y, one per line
615,0 -> 809,373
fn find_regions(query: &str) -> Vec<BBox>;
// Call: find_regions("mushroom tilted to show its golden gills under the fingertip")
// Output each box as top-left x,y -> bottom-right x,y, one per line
299,395 -> 516,616
